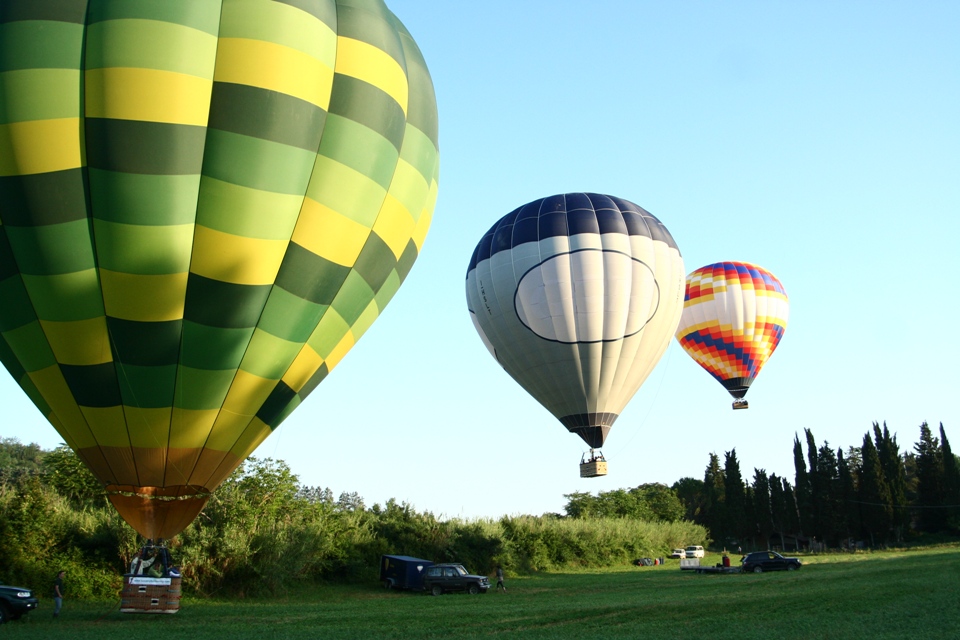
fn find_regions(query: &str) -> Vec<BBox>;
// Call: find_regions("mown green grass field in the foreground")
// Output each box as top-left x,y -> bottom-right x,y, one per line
0,546 -> 960,640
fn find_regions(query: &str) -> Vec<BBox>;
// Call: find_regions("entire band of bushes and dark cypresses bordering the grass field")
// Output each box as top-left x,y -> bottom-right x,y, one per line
0,423 -> 960,596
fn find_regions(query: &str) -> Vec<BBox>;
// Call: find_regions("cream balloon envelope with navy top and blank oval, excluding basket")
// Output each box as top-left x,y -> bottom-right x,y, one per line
466,193 -> 684,447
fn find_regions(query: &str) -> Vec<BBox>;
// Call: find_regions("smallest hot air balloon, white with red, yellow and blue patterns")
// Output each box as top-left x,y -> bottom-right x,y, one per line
676,262 -> 790,409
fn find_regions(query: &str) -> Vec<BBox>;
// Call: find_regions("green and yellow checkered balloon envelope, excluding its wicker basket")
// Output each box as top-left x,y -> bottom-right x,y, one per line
0,0 -> 439,538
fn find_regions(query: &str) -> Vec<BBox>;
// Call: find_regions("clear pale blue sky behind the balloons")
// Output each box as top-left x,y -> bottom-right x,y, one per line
0,0 -> 960,518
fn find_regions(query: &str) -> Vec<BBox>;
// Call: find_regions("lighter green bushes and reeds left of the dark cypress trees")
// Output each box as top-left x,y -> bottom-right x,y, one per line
0,438 -> 708,597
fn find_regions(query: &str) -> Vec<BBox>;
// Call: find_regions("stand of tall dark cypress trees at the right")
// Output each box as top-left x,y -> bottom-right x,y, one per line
672,422 -> 960,550
